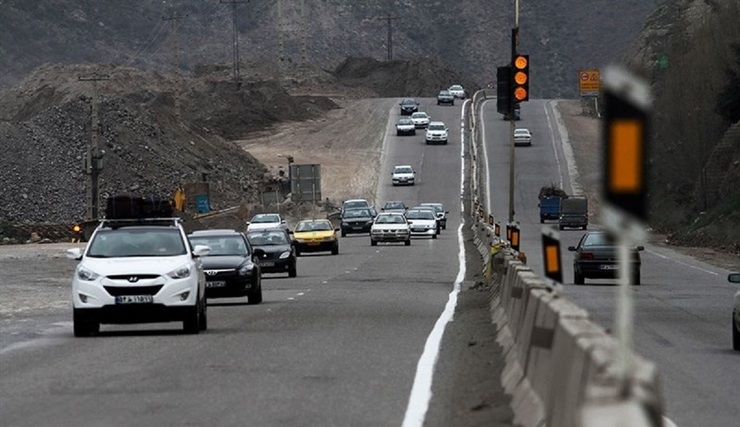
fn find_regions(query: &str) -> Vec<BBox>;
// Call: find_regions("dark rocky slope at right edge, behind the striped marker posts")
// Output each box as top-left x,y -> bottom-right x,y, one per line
626,0 -> 740,253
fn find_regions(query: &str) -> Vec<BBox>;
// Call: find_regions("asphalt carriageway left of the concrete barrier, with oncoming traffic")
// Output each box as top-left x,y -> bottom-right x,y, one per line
0,99 -> 510,427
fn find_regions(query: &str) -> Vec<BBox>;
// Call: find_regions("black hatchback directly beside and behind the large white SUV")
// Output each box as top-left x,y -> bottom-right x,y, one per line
188,230 -> 262,304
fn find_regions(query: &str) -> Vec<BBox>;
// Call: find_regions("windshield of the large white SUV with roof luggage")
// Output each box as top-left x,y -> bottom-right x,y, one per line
87,227 -> 187,258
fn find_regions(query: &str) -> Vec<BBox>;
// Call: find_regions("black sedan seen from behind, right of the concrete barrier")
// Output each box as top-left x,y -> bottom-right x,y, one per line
568,231 -> 645,285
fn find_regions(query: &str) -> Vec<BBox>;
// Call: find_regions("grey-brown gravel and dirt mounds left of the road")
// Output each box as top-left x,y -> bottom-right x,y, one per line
0,58 -> 462,223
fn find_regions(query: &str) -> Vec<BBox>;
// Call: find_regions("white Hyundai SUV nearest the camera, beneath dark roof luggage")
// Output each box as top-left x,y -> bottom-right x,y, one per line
67,218 -> 210,337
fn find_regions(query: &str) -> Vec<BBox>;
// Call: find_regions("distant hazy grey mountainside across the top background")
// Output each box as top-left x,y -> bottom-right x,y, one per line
0,0 -> 660,98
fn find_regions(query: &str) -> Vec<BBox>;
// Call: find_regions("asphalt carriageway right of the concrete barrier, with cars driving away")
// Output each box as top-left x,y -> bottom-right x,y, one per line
483,100 -> 740,426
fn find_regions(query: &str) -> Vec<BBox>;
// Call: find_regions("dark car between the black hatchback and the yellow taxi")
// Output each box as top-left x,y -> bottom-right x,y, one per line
247,228 -> 297,277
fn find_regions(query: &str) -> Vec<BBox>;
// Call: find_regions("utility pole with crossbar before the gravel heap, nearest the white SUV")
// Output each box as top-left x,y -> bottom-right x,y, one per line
77,74 -> 110,220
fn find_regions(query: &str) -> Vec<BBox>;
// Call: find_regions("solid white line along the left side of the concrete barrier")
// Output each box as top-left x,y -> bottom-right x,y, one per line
402,101 -> 472,427
